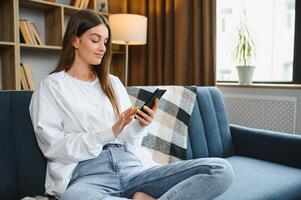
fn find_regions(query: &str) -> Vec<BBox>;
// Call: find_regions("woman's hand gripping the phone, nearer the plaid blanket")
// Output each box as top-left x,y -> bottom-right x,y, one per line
135,98 -> 158,126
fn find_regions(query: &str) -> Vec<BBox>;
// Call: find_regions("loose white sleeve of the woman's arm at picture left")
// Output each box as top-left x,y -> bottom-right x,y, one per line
29,81 -> 116,163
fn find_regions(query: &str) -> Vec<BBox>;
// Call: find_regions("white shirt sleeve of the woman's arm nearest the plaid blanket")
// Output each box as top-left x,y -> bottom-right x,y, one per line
110,77 -> 147,146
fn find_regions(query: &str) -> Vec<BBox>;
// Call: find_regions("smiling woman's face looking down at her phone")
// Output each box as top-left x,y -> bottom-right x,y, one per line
73,24 -> 109,65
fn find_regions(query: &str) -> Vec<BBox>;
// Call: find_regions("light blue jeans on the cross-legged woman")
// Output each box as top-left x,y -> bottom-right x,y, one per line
61,144 -> 233,200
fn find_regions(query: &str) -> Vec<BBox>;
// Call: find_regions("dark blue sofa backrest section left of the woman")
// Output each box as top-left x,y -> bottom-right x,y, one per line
0,91 -> 46,200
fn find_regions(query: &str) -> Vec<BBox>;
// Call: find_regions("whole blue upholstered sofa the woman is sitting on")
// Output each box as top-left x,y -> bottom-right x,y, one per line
0,87 -> 301,200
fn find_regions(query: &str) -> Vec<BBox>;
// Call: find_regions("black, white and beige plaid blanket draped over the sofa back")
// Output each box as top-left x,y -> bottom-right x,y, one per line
127,86 -> 196,164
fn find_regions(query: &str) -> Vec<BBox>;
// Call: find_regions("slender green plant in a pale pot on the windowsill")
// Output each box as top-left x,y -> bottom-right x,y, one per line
235,10 -> 255,84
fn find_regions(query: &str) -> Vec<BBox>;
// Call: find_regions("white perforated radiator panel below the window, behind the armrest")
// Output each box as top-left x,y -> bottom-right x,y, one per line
223,94 -> 297,133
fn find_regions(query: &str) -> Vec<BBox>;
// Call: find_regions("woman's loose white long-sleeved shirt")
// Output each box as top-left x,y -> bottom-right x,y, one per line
29,70 -> 154,197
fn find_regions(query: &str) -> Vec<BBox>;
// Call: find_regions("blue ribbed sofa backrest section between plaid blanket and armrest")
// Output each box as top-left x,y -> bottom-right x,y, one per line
189,87 -> 234,158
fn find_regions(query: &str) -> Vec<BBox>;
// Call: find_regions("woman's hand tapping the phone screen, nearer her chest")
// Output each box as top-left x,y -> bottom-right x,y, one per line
112,107 -> 137,137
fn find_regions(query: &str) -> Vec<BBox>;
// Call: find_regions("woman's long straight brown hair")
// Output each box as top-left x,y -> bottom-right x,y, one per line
50,10 -> 120,114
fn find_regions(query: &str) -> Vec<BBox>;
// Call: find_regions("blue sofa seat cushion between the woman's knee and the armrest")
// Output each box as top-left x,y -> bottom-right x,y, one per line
217,156 -> 301,200
